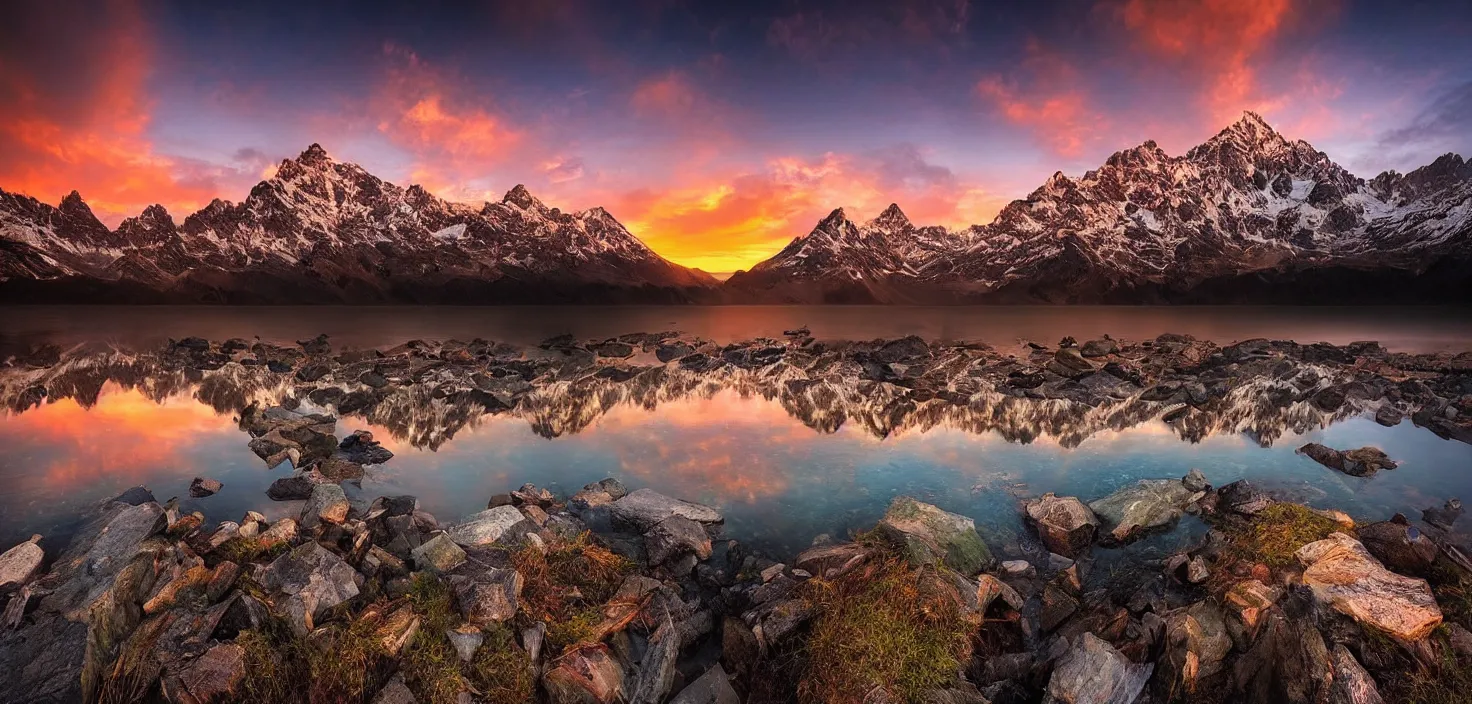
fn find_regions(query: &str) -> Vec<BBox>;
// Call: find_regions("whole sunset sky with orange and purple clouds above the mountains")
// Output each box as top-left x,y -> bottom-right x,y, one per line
0,0 -> 1472,272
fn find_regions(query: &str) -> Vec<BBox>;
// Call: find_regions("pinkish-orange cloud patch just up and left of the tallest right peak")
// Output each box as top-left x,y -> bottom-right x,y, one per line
976,41 -> 1108,158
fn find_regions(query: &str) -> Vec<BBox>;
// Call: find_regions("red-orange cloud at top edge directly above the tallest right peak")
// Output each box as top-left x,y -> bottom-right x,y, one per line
1119,0 -> 1298,124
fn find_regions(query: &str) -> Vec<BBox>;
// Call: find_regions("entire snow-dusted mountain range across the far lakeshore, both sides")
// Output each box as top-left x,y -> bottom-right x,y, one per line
0,113 -> 1472,303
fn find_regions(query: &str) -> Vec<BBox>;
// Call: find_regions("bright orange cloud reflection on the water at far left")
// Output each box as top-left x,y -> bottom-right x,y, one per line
0,383 -> 243,489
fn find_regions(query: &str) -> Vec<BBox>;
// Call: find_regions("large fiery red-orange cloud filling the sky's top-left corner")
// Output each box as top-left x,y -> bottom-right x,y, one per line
0,1 -> 218,225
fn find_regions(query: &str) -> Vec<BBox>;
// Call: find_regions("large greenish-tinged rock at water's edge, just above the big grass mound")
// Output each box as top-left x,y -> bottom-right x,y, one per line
876,496 -> 992,576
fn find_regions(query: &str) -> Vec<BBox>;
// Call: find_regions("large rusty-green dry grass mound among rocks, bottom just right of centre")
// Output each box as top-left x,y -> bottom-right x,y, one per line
798,557 -> 972,704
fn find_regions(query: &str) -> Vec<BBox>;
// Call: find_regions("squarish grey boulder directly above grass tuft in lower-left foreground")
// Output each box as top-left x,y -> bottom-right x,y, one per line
258,542 -> 362,636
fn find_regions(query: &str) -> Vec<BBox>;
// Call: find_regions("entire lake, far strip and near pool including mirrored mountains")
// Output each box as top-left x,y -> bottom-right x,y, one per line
0,308 -> 1472,574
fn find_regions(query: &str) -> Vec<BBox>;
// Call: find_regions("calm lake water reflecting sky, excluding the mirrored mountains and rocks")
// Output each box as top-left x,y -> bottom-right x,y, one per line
0,308 -> 1472,568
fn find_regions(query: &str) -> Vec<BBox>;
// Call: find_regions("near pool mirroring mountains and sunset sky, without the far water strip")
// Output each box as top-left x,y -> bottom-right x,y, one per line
0,335 -> 1472,554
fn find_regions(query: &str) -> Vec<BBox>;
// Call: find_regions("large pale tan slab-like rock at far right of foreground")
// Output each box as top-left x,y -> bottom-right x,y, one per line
1294,533 -> 1441,641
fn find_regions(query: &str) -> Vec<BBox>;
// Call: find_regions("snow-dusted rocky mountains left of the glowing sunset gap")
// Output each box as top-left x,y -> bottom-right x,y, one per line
0,144 -> 717,303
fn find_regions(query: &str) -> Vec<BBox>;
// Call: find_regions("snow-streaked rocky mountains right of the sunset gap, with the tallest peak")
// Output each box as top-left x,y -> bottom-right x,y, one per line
727,113 -> 1472,303
